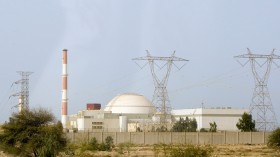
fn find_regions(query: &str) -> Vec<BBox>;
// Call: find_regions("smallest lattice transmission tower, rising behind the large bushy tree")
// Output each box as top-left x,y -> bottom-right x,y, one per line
10,71 -> 33,112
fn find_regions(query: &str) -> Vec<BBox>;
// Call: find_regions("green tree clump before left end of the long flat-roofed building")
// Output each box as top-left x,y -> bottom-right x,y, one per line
171,117 -> 197,132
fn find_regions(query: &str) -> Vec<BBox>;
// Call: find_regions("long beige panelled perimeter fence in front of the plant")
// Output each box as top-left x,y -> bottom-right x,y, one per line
67,131 -> 271,145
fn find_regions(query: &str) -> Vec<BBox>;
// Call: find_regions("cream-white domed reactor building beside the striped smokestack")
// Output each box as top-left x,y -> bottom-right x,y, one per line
69,93 -> 156,132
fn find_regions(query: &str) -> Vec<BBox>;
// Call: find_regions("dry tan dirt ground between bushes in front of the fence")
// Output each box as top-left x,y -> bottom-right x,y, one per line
0,145 -> 280,157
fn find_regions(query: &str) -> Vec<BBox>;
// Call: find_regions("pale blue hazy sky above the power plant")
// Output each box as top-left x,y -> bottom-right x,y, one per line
0,0 -> 280,125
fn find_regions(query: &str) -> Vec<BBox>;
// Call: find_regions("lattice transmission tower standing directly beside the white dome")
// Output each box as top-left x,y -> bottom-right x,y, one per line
132,50 -> 188,123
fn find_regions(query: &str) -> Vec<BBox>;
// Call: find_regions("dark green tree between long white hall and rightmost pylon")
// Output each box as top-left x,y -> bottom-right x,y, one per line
236,112 -> 256,132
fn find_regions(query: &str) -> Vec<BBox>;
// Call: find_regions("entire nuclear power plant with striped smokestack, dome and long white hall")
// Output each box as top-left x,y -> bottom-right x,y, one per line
61,49 -> 248,132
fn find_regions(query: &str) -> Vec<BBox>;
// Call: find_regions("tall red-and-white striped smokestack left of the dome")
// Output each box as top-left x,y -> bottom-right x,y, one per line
61,49 -> 68,128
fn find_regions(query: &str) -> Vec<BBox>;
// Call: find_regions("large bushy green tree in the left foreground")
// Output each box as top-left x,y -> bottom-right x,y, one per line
0,108 -> 66,157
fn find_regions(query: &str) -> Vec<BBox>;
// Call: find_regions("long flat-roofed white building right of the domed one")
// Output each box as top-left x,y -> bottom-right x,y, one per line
172,107 -> 248,131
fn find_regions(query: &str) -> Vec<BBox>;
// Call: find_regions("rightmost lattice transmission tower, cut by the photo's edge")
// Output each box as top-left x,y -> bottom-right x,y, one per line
235,49 -> 280,131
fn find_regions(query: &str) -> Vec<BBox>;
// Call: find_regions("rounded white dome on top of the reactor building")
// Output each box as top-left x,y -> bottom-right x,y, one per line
104,93 -> 155,114
